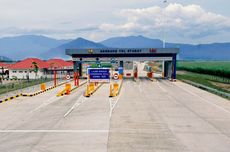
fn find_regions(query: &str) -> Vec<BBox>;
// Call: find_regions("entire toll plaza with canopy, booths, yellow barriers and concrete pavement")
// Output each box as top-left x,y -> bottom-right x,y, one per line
0,48 -> 230,152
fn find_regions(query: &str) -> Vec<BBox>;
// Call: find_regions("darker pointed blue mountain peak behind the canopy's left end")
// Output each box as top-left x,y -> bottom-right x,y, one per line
42,38 -> 106,59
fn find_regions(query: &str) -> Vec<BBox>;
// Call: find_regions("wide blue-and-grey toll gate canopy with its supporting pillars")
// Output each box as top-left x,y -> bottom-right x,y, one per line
66,48 -> 179,79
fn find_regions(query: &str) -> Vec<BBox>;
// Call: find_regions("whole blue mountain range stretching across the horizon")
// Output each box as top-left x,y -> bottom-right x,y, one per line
0,35 -> 230,60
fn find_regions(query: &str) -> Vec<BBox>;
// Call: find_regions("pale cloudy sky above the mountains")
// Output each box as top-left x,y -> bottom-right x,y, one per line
0,0 -> 230,44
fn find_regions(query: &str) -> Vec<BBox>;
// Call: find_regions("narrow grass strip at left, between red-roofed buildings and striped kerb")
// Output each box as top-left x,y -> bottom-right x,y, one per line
0,79 -> 51,94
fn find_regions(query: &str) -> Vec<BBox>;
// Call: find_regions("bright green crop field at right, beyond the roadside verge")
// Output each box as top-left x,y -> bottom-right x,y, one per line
177,61 -> 230,78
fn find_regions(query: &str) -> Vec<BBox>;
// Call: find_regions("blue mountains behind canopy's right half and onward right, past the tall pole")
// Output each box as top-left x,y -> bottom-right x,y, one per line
101,36 -> 230,60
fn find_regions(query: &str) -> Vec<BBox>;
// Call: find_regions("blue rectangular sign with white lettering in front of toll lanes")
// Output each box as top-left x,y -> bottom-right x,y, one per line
88,68 -> 110,82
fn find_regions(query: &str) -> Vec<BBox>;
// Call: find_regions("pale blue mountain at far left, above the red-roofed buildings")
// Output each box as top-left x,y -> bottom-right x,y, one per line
0,35 -> 69,60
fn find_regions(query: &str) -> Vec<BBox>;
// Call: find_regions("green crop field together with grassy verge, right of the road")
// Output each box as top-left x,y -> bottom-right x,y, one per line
177,61 -> 230,98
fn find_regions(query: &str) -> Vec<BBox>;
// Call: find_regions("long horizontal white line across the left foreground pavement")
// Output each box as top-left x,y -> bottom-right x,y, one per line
0,130 -> 109,133
